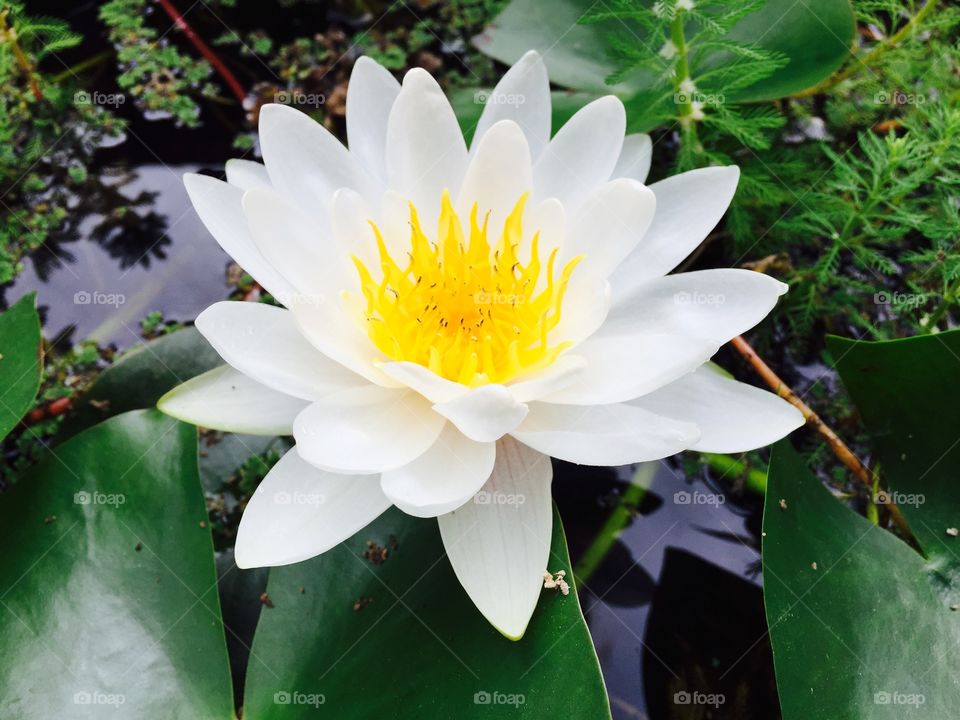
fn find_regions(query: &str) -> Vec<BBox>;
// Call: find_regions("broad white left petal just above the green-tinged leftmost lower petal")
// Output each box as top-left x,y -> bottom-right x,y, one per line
196,302 -> 366,400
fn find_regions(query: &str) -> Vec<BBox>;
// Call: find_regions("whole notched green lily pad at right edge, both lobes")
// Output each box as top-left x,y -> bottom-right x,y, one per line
763,332 -> 960,720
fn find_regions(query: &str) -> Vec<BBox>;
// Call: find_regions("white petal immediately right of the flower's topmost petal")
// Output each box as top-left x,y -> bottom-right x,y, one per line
533,95 -> 627,212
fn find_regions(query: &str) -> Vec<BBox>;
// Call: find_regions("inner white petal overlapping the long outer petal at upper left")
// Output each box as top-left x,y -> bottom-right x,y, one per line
243,188 -> 356,300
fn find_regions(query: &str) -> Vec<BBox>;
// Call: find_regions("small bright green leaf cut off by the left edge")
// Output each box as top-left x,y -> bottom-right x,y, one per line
0,293 -> 41,440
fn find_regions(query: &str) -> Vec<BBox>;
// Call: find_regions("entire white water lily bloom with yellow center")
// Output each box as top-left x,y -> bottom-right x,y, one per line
159,52 -> 803,639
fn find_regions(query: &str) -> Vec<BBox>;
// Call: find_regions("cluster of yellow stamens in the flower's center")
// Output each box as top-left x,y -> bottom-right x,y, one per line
353,192 -> 582,387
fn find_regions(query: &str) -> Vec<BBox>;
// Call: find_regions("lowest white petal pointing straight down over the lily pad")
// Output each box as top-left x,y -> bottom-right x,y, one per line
438,437 -> 553,640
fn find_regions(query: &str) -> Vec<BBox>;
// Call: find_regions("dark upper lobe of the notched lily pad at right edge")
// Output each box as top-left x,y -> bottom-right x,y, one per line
827,330 -> 960,560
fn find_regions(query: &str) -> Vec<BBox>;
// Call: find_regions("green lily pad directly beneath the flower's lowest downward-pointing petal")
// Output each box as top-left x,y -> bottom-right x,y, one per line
244,509 -> 610,720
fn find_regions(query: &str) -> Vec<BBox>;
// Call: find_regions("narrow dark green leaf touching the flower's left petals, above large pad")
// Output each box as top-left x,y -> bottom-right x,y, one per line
57,327 -> 223,441
